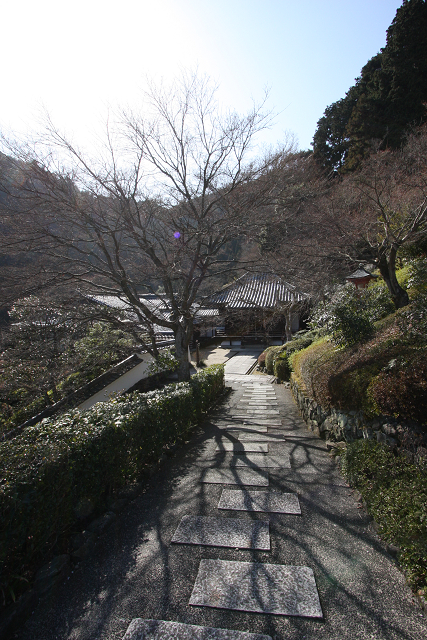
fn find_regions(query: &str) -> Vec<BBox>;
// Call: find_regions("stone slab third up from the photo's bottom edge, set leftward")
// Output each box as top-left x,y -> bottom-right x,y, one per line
172,516 -> 270,551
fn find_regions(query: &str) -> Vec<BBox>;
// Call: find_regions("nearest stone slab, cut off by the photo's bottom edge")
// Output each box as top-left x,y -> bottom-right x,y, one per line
123,618 -> 272,640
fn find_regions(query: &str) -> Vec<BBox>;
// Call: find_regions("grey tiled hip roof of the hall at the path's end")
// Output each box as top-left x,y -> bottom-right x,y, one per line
209,273 -> 307,309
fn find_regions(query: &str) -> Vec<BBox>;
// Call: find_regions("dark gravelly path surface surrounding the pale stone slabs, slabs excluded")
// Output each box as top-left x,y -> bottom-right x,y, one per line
16,375 -> 427,640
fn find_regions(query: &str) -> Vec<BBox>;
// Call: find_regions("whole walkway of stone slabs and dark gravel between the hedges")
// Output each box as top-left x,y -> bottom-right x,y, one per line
17,378 -> 427,640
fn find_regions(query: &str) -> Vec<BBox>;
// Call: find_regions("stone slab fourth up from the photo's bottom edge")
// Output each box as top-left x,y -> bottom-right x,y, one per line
218,489 -> 301,515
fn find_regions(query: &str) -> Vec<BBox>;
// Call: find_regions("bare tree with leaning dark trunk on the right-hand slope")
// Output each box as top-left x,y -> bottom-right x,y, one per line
330,126 -> 427,309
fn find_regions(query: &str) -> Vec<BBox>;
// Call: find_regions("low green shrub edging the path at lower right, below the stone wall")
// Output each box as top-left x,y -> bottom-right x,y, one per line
342,440 -> 427,595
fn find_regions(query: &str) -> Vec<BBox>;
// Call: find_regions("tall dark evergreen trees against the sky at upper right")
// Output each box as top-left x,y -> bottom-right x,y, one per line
313,0 -> 427,172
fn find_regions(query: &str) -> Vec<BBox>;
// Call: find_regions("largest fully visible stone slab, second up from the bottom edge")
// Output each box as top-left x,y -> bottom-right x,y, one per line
190,559 -> 323,618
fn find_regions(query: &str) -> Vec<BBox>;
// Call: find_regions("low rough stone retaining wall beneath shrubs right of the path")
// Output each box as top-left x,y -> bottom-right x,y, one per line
290,377 -> 427,463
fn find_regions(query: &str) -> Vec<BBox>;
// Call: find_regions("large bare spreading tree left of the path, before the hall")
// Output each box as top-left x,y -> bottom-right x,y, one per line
1,76 -> 292,380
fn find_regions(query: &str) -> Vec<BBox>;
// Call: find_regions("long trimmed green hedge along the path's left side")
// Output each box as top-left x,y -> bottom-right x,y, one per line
0,365 -> 224,594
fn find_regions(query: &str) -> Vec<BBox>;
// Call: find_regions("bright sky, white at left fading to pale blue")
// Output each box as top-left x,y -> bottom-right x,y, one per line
0,0 -> 402,149
